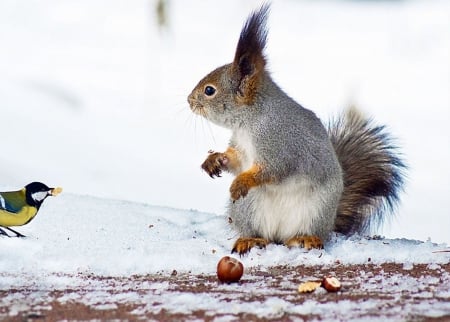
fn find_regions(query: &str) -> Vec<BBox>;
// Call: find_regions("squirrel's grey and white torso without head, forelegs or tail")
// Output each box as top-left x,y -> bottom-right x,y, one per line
228,74 -> 343,243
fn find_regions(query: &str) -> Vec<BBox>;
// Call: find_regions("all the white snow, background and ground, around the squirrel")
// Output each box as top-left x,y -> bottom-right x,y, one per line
0,0 -> 450,320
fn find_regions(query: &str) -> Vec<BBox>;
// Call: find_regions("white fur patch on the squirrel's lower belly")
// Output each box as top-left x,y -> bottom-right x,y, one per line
251,176 -> 328,242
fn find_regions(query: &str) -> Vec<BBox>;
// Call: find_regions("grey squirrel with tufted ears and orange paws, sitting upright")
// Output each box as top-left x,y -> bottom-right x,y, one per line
188,4 -> 406,255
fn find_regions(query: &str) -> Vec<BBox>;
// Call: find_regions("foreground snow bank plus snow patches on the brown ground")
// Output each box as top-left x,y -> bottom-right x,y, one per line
0,192 -> 450,319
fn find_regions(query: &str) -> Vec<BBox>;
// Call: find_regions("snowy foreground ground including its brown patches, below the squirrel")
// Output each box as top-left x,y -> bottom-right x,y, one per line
0,193 -> 450,321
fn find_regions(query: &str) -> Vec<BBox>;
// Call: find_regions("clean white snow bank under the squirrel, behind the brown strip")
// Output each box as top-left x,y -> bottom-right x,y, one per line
0,194 -> 450,277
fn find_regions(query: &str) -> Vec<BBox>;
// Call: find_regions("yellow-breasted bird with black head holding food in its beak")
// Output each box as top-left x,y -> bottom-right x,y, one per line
0,182 -> 62,237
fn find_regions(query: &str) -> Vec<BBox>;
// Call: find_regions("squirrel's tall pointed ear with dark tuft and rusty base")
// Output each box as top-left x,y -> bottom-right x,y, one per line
232,4 -> 269,104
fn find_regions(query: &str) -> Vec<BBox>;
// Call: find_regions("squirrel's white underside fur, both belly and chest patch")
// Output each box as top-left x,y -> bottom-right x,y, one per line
234,130 -> 333,243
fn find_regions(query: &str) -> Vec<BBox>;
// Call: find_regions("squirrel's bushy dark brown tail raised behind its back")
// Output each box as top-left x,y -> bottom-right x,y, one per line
328,107 -> 406,235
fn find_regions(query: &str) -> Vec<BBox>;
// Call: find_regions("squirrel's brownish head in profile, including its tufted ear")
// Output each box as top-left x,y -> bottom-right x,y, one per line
188,5 -> 269,127
